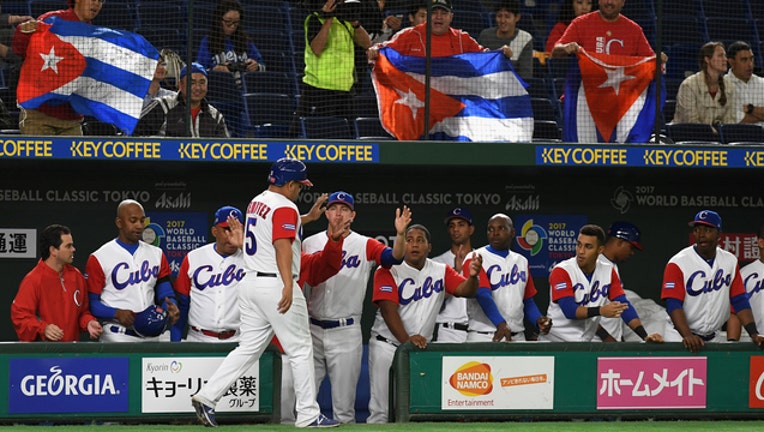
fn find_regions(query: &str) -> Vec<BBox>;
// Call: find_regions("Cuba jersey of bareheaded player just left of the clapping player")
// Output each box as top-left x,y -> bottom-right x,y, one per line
462,246 -> 536,332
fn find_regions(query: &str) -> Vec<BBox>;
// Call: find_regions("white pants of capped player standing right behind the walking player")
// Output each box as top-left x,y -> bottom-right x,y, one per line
310,320 -> 363,423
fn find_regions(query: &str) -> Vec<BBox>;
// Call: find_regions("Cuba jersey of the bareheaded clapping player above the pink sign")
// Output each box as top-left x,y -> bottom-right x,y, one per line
547,257 -> 625,342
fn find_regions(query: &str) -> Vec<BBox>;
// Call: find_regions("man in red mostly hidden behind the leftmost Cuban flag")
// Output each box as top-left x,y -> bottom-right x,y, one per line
12,0 -> 105,135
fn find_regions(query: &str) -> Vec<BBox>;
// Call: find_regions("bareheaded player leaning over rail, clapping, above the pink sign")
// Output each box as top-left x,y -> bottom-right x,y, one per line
539,225 -> 663,342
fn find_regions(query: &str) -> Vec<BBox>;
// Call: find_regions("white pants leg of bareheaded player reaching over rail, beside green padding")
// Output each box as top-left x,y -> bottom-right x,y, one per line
366,333 -> 398,423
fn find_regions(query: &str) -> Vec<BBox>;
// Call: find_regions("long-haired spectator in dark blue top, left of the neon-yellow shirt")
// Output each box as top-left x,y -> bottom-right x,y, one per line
196,0 -> 265,82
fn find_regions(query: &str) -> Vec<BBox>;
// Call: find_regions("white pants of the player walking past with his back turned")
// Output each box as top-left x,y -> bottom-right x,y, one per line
196,272 -> 320,427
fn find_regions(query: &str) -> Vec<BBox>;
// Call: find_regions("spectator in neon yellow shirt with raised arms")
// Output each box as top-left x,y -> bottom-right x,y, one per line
290,0 -> 371,136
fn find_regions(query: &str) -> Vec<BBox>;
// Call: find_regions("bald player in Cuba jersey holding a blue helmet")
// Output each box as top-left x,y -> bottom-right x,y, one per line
85,200 -> 180,342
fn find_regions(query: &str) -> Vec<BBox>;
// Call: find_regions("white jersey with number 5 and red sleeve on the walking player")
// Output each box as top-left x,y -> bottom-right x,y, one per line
243,190 -> 302,278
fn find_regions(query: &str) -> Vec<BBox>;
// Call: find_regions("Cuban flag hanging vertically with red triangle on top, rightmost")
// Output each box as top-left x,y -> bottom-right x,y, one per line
563,50 -> 665,143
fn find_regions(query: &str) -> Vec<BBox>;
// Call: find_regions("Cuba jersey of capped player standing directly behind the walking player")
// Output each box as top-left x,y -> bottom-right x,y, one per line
302,231 -> 387,320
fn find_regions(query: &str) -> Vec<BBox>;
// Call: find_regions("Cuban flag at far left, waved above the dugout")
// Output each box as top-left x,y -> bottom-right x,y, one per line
16,17 -> 159,135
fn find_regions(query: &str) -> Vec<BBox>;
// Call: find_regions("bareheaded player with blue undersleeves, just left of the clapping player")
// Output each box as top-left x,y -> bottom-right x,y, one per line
464,213 -> 552,342
